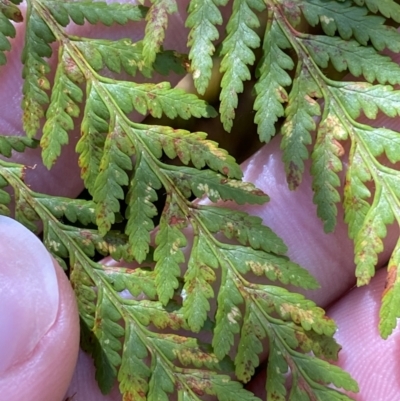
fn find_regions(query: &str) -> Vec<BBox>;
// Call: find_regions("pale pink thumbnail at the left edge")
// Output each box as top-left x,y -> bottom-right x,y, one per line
0,216 -> 59,375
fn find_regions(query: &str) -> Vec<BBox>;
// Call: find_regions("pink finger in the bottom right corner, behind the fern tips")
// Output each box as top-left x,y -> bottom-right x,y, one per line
328,269 -> 400,401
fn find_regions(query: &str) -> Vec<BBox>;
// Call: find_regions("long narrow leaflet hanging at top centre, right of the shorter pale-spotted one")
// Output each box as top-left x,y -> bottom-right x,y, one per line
219,0 -> 265,132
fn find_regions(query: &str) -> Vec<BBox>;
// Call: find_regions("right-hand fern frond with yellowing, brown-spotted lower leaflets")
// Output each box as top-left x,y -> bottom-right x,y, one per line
250,0 -> 400,340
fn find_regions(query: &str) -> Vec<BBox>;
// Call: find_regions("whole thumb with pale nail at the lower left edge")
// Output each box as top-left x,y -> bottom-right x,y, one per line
0,216 -> 79,401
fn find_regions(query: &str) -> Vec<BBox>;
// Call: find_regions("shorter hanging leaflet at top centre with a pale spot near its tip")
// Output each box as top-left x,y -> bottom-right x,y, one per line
185,0 -> 227,95
